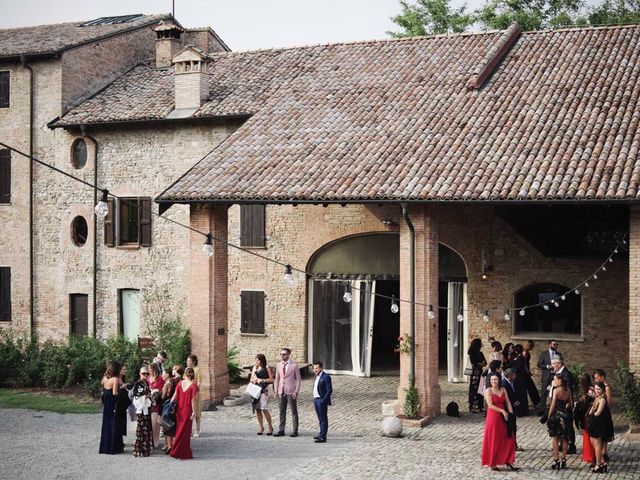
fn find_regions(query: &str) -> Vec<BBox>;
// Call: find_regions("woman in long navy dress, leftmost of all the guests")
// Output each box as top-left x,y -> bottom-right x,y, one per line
99,362 -> 124,455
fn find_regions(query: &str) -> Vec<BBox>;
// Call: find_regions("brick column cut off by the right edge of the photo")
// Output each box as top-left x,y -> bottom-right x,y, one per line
629,205 -> 640,375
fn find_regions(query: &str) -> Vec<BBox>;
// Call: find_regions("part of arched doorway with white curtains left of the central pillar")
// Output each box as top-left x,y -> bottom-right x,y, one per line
308,233 -> 400,376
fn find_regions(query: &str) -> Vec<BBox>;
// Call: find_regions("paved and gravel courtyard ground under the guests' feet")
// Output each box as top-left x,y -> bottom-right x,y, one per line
0,376 -> 640,480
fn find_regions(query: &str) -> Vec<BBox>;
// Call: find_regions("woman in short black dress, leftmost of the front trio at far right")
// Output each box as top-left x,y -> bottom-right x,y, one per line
547,374 -> 573,470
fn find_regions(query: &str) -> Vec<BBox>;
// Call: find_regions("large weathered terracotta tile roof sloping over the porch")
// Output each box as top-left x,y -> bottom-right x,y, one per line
62,26 -> 640,202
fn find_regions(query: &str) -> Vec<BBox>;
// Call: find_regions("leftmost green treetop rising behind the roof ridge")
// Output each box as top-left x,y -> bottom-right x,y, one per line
388,0 -> 474,38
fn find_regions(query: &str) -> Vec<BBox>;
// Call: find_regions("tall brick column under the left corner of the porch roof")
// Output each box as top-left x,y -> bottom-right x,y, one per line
188,205 -> 229,410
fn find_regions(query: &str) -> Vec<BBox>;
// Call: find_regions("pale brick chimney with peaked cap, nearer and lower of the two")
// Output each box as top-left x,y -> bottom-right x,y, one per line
173,45 -> 209,110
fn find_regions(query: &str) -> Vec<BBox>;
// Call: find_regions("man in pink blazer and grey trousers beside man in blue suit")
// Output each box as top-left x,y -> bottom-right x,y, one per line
273,348 -> 302,437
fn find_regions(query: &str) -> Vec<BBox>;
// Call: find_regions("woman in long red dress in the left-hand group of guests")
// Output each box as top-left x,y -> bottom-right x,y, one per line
169,368 -> 198,459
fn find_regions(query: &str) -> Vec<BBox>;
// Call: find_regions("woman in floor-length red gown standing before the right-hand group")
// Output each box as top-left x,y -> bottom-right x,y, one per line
482,373 -> 520,470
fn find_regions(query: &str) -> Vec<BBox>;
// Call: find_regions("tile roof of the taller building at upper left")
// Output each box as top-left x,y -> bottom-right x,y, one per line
0,14 -> 171,60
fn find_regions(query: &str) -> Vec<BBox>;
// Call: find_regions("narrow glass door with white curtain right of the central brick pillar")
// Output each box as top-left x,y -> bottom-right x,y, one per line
447,282 -> 468,382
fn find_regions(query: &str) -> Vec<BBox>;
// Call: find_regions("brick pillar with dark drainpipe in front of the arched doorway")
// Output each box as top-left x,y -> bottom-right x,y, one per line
398,206 -> 440,417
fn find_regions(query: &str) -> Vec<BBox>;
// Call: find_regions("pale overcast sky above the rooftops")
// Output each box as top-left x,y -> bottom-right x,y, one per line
0,0 -> 490,50
